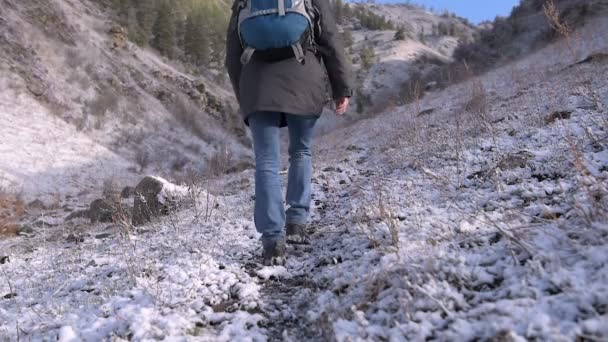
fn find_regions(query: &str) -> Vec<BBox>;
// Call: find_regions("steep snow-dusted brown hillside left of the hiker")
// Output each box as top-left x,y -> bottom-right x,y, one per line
0,0 -> 250,202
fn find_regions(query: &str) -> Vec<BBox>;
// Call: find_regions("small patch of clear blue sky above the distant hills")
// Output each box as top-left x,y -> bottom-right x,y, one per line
377,0 -> 519,24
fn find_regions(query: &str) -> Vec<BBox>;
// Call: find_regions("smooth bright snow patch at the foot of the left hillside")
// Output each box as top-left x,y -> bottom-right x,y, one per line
0,79 -> 133,202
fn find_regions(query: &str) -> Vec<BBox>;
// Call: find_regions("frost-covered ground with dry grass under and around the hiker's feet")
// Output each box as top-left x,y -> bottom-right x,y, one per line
0,18 -> 608,341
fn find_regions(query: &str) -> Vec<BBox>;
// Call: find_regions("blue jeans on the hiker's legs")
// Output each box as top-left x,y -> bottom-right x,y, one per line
248,112 -> 317,242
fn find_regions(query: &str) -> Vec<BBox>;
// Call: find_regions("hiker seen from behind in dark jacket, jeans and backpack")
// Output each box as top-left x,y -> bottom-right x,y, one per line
226,0 -> 352,265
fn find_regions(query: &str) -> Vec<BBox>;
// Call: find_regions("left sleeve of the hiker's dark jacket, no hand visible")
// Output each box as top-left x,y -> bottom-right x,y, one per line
225,0 -> 243,103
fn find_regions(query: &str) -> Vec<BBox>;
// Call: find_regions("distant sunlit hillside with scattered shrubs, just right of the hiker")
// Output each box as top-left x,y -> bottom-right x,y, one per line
314,2 -> 479,131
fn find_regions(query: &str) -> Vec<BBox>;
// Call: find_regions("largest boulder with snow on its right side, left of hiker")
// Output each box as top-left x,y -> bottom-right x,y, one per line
131,176 -> 189,227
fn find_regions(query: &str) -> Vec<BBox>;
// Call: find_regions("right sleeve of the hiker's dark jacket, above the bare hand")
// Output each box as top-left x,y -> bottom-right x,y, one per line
313,0 -> 353,100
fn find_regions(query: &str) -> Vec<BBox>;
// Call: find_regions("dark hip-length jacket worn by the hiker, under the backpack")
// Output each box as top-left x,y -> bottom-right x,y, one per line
226,0 -> 352,122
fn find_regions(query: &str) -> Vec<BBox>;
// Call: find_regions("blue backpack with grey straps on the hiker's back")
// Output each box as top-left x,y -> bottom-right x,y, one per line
238,0 -> 317,64
